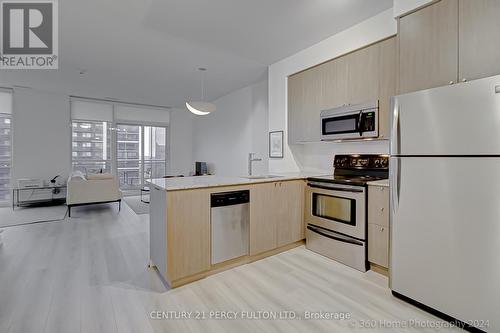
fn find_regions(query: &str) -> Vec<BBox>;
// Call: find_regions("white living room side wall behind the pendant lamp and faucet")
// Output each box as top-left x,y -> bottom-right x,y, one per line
193,80 -> 268,176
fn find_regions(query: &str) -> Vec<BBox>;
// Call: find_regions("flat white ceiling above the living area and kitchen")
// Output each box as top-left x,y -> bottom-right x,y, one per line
0,0 -> 393,106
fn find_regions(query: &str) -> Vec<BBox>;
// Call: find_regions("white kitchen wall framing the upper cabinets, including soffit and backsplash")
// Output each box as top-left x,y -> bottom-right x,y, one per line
268,8 -> 397,173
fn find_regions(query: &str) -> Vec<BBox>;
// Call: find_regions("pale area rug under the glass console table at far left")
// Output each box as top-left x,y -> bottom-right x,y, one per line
0,205 -> 68,228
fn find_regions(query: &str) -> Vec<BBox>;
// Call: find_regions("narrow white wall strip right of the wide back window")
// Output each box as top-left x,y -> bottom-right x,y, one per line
168,109 -> 194,176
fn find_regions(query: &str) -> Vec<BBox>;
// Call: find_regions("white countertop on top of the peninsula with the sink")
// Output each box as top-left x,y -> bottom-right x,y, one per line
149,172 -> 320,191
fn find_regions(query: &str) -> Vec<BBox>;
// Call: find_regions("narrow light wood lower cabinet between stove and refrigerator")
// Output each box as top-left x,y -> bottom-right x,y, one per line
368,186 -> 389,268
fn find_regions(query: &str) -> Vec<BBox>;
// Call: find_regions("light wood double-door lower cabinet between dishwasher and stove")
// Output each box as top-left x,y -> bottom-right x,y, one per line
250,180 -> 305,255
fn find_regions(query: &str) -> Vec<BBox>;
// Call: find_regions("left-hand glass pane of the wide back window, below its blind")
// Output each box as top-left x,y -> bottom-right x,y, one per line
71,120 -> 111,172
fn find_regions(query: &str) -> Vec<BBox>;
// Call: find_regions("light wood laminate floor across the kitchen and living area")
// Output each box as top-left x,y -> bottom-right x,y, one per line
0,205 -> 460,333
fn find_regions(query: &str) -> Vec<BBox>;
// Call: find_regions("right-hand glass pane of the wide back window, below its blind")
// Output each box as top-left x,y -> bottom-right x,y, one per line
116,124 -> 167,189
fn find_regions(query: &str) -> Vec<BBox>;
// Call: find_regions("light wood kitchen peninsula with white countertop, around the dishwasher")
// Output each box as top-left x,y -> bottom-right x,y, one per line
146,173 -> 311,288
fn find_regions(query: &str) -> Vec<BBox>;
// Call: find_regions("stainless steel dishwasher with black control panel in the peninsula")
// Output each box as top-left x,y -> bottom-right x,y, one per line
211,190 -> 250,264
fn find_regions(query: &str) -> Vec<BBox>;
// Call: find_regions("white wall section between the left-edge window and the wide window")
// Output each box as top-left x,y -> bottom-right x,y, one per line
11,88 -> 71,182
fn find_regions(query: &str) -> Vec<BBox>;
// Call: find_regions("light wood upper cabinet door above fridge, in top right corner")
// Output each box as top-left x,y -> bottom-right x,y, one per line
459,0 -> 500,80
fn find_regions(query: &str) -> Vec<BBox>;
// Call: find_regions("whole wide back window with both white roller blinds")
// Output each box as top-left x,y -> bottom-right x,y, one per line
71,98 -> 170,190
